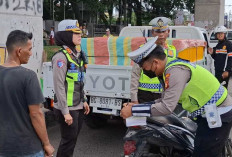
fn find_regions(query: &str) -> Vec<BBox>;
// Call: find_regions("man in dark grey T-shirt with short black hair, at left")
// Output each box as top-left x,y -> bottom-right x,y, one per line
0,30 -> 54,157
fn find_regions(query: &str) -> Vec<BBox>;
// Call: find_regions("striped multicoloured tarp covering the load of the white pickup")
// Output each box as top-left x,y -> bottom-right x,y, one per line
81,37 -> 205,65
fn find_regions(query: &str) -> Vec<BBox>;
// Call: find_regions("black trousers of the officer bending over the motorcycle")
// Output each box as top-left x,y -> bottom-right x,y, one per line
193,117 -> 232,157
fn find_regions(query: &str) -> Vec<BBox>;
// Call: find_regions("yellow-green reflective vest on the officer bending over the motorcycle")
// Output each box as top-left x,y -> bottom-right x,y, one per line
165,58 -> 227,117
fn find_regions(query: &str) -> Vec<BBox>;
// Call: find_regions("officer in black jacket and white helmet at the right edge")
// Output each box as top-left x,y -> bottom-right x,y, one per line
208,26 -> 232,88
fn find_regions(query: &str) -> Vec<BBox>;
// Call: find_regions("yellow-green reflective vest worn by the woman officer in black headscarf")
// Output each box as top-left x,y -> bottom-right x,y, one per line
62,49 -> 85,107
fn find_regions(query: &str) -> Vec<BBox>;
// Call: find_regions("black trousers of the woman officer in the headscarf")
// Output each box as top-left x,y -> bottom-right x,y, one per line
54,108 -> 84,157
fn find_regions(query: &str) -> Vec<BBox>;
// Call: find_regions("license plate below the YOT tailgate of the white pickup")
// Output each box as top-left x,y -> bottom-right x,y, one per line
90,96 -> 122,110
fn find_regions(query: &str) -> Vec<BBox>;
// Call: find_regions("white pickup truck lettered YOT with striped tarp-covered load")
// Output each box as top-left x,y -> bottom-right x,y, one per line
43,26 -> 214,128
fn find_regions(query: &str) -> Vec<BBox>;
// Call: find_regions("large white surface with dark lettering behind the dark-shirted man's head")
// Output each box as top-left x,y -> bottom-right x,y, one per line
0,0 -> 43,79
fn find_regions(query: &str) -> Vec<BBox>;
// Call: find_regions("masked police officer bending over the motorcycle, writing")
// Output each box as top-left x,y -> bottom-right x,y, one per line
121,39 -> 232,157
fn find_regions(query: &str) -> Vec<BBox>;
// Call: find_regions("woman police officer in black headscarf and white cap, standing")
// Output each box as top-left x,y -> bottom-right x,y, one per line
52,20 -> 89,157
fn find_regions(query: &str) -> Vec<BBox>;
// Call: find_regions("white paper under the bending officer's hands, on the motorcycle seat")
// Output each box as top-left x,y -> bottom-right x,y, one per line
126,116 -> 147,127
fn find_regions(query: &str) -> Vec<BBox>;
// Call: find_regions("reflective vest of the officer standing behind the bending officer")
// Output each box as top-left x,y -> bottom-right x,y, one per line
139,45 -> 176,93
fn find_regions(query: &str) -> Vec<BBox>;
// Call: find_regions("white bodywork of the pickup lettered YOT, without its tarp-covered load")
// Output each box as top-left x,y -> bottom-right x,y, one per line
43,27 -> 213,116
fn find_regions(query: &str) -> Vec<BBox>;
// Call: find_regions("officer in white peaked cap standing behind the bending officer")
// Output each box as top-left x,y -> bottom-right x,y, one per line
130,17 -> 176,103
